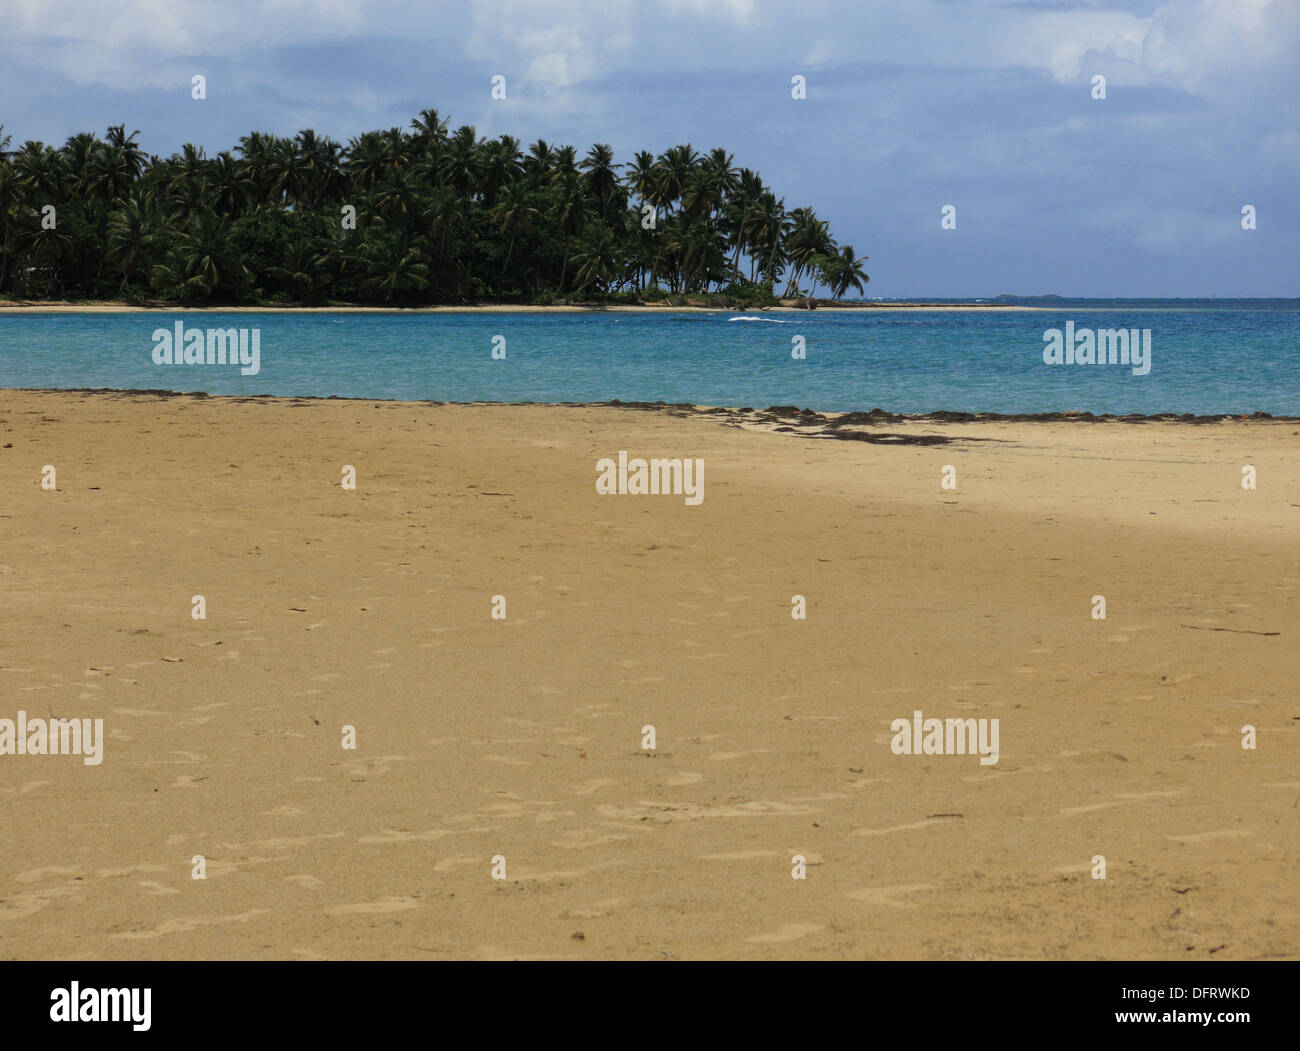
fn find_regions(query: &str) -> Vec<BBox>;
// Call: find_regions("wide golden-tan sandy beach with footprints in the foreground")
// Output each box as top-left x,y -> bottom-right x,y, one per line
0,387 -> 1300,960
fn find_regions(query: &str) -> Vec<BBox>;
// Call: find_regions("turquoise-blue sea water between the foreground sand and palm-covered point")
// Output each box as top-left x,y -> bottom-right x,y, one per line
0,300 -> 1300,415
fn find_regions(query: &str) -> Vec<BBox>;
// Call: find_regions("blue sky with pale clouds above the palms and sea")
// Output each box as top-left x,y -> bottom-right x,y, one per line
0,0 -> 1300,298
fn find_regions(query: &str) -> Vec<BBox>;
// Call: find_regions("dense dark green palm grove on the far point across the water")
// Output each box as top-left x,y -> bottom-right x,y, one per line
0,109 -> 868,306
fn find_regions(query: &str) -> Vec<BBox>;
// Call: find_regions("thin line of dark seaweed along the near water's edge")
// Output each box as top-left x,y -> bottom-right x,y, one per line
0,386 -> 1300,424
